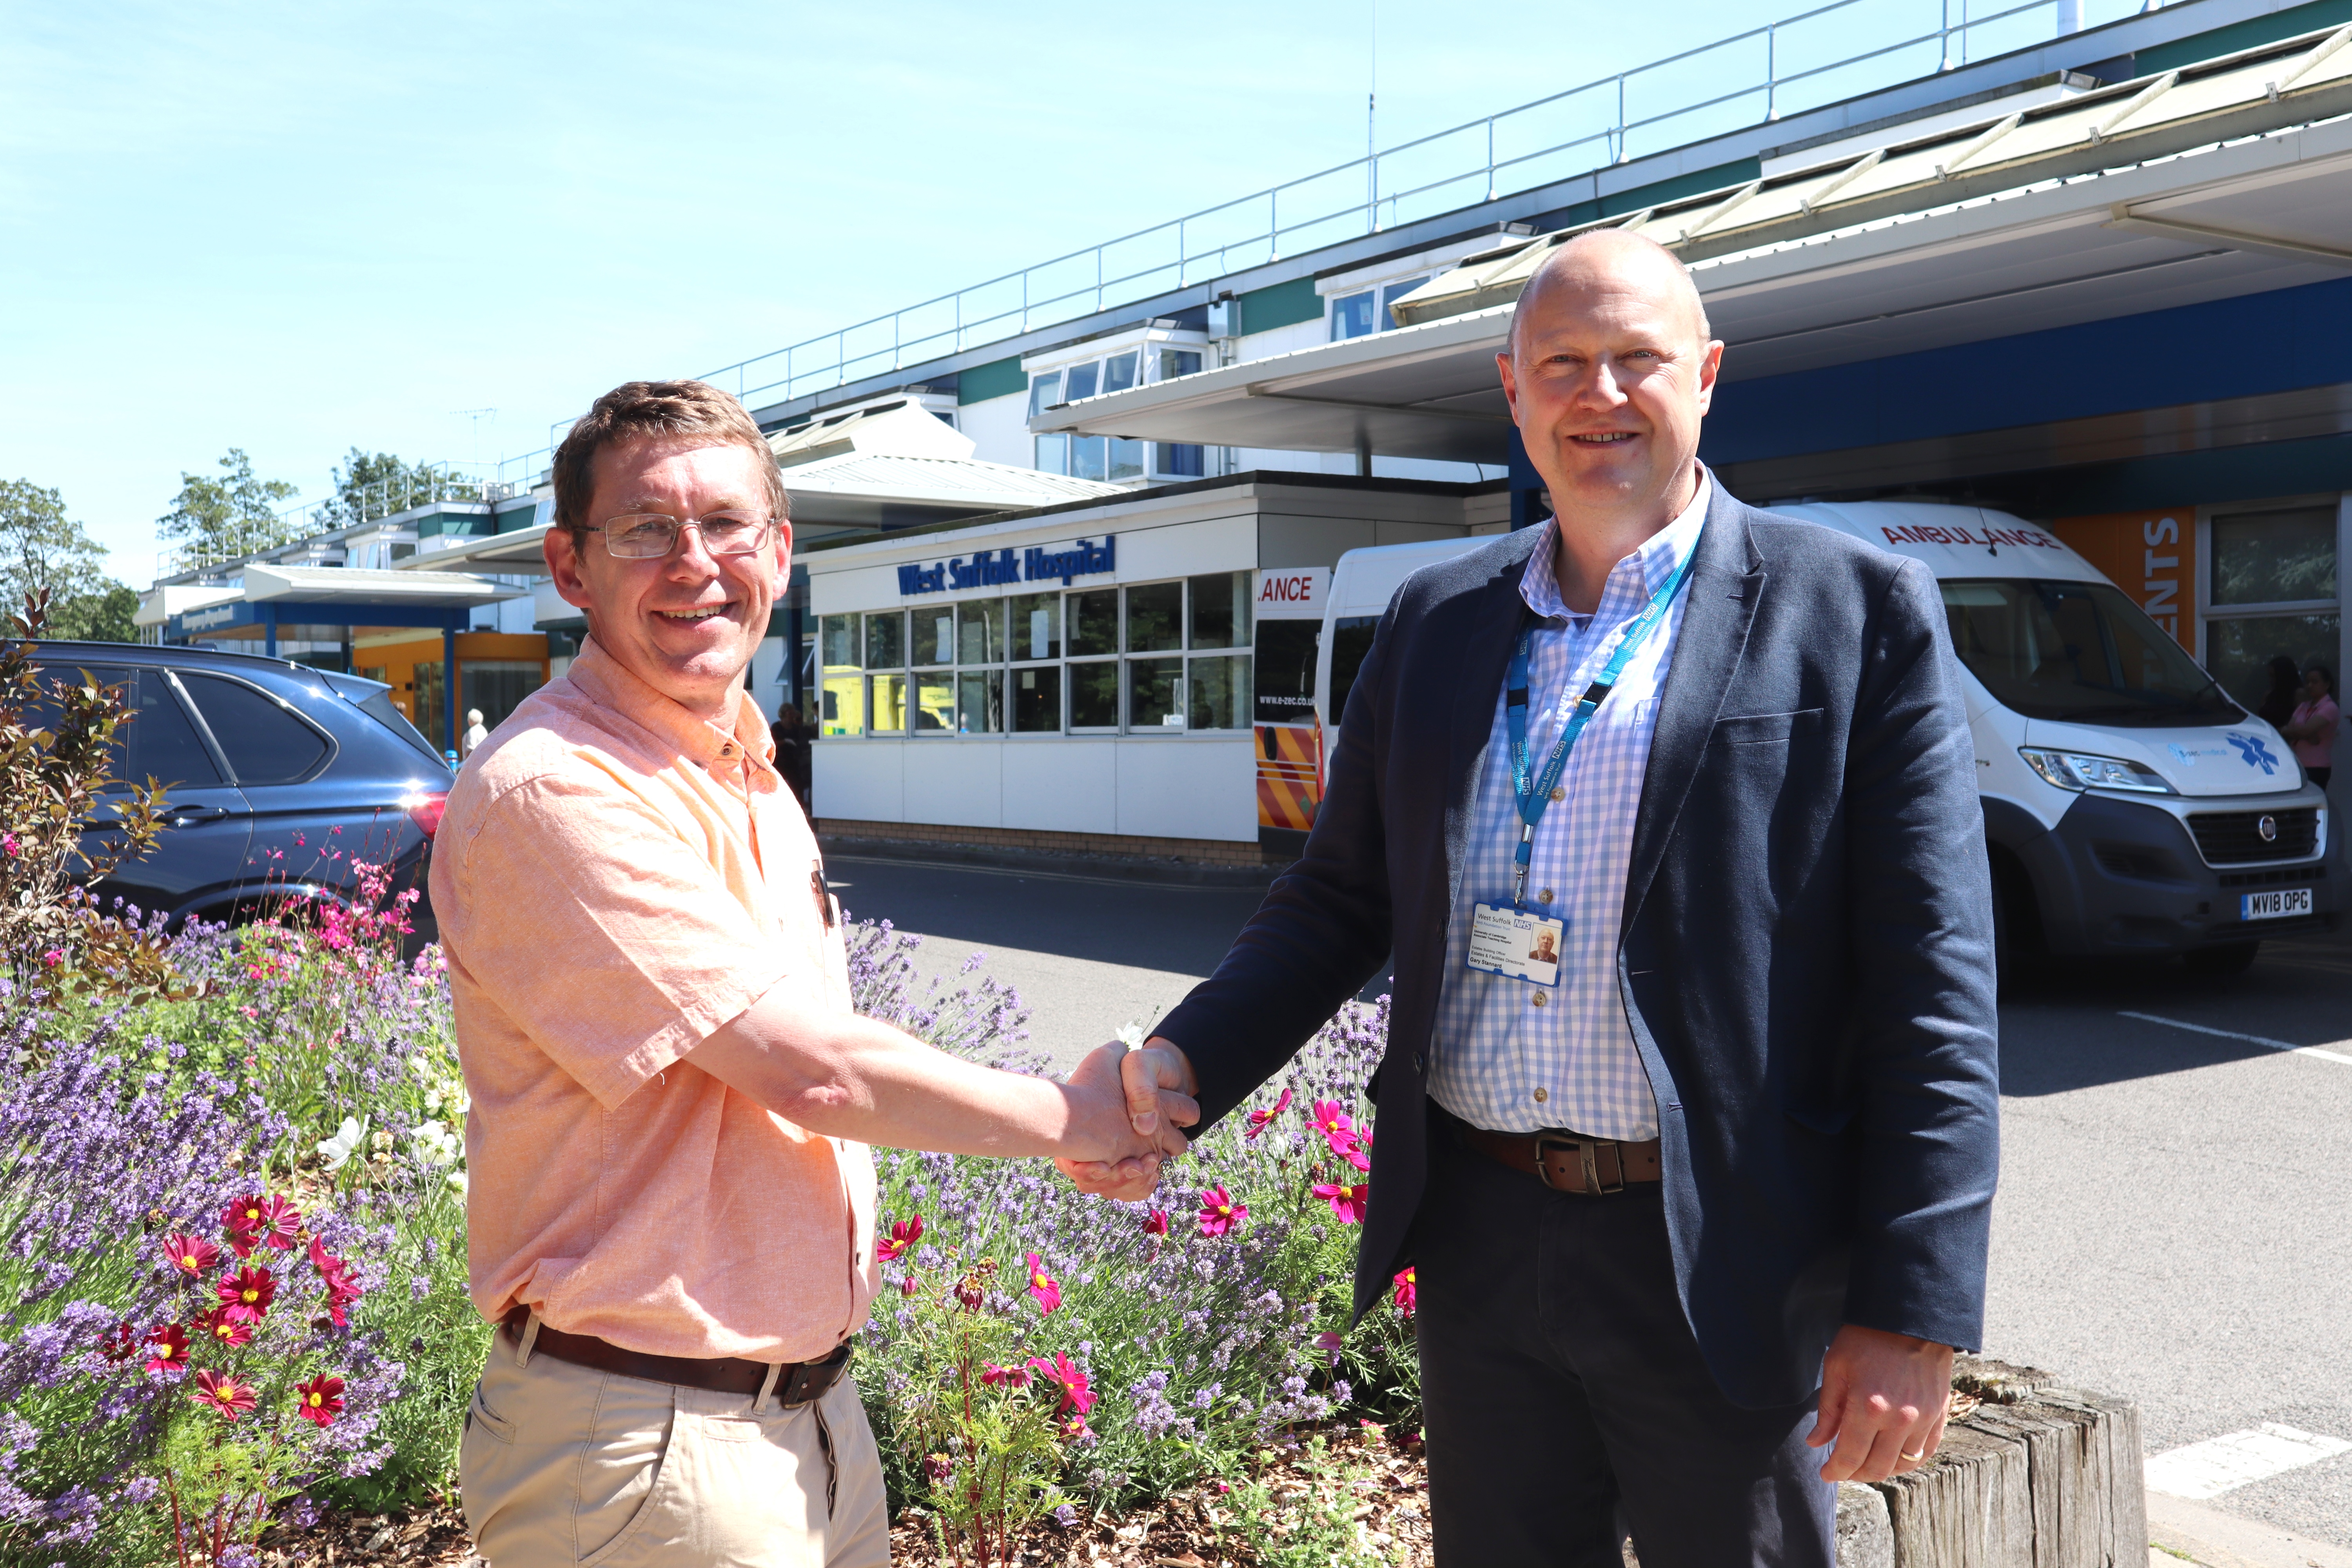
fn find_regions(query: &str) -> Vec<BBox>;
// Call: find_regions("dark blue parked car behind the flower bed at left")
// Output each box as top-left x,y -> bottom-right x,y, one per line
35,642 -> 449,936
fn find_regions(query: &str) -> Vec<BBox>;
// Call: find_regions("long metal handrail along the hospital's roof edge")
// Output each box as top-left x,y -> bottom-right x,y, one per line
499,0 -> 2180,484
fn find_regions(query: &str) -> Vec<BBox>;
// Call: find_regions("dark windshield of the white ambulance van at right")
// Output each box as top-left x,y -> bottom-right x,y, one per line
1943,578 -> 2244,729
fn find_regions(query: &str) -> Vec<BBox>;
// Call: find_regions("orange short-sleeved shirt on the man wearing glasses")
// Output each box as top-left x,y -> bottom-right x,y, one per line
433,639 -> 877,1361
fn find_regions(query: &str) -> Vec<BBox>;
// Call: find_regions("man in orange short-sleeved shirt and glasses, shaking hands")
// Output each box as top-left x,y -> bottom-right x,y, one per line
433,381 -> 1188,1568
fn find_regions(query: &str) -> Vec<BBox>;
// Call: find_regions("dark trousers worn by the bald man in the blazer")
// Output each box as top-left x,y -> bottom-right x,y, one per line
1414,1105 -> 1837,1568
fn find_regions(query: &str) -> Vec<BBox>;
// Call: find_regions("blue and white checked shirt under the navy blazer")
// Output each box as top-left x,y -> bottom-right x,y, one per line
1430,470 -> 1712,1143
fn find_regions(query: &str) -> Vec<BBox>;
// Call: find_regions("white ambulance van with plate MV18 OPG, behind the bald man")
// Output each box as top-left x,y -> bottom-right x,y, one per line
1315,501 -> 2343,973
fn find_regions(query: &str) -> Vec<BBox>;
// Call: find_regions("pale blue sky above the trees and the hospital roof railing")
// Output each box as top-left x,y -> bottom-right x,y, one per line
0,0 -> 1872,588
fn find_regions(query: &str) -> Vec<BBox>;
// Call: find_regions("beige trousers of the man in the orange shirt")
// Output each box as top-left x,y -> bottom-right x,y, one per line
459,1328 -> 889,1568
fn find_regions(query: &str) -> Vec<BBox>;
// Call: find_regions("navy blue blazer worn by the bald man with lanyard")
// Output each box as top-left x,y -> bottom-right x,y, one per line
1157,484 -> 1999,1406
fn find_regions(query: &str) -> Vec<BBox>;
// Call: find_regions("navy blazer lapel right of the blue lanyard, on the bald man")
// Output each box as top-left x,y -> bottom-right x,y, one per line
1618,491 -> 1764,933
